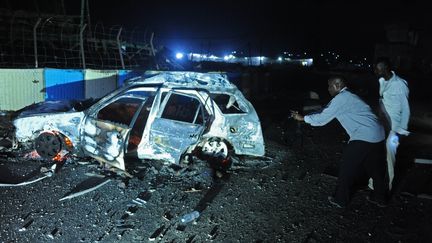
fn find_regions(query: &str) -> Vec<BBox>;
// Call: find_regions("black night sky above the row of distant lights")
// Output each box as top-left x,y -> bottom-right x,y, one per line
7,0 -> 432,55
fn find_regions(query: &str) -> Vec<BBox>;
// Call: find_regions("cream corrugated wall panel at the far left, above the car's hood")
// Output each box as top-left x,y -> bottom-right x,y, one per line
0,69 -> 45,110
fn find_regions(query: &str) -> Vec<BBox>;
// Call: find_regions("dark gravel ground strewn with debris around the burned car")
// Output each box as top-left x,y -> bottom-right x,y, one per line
0,116 -> 432,242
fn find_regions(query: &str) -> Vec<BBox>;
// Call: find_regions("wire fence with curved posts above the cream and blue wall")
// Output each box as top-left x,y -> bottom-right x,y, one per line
0,9 -> 156,69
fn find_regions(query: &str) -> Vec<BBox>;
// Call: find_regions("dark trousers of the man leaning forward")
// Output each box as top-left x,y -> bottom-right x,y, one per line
334,140 -> 388,206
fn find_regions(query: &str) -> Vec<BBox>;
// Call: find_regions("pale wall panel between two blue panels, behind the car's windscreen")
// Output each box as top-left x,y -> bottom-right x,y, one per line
84,69 -> 117,98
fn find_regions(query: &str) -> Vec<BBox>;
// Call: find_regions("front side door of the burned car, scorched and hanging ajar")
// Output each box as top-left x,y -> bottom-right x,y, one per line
81,94 -> 147,170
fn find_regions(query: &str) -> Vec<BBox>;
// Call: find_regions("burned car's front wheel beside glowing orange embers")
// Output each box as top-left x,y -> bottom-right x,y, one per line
35,132 -> 62,159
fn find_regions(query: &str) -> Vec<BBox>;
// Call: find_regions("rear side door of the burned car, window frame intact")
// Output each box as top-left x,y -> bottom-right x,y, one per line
149,91 -> 208,163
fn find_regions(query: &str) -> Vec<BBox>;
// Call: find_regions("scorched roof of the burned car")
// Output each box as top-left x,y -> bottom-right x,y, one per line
128,71 -> 237,92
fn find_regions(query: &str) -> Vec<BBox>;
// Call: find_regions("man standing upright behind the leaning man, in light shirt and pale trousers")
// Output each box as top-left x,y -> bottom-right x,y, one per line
374,58 -> 410,190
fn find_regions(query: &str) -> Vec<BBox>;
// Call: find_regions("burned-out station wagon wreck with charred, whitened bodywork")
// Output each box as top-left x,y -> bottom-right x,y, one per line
1,71 -> 265,174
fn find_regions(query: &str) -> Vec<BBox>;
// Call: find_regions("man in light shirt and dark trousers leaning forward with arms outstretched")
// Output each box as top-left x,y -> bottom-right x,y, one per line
291,76 -> 388,207
